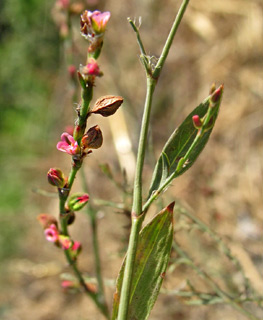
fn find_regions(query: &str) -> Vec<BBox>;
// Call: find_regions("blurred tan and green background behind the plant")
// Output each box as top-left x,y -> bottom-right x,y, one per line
0,0 -> 263,320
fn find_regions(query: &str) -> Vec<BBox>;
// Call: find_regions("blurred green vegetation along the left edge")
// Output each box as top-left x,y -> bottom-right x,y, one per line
0,0 -> 59,259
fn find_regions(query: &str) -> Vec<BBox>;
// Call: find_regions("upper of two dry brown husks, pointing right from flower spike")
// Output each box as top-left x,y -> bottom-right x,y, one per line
91,96 -> 123,117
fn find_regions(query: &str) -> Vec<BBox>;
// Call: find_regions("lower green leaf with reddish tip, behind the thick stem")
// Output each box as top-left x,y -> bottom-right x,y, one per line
112,202 -> 174,320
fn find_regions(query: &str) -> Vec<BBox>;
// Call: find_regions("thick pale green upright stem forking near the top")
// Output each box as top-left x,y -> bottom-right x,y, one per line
118,0 -> 190,320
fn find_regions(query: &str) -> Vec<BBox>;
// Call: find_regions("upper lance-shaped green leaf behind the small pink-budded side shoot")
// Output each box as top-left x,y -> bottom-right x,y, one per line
149,86 -> 223,197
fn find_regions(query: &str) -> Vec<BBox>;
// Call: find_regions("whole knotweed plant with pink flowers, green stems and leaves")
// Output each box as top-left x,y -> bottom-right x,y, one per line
38,0 -> 263,320
